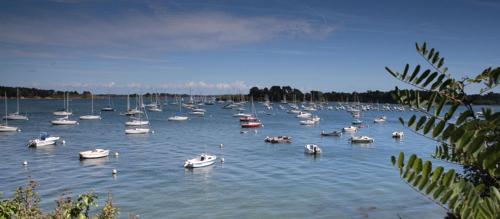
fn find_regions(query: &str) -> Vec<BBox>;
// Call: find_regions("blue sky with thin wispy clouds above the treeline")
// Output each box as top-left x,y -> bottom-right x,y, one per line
0,0 -> 500,94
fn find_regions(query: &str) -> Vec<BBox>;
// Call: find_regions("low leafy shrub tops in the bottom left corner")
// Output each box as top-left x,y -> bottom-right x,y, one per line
0,181 -> 118,219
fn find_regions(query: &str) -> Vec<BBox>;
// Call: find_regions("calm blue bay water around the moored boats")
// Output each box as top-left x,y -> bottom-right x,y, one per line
0,100 -> 468,218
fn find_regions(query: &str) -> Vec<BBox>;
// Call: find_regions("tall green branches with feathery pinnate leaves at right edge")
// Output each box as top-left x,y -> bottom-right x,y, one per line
386,43 -> 500,218
